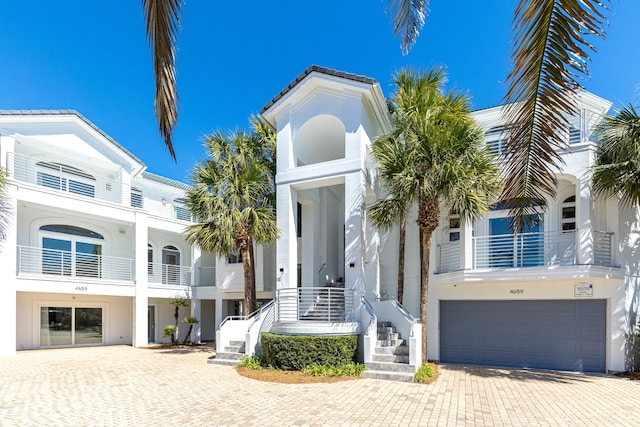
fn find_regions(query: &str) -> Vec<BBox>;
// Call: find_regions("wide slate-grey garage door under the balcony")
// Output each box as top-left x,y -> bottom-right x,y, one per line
440,300 -> 606,372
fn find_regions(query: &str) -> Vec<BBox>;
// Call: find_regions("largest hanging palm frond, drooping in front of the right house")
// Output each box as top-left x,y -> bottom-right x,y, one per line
503,0 -> 609,229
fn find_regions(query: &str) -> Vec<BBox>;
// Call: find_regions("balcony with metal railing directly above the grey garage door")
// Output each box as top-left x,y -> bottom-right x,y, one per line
438,230 -> 613,273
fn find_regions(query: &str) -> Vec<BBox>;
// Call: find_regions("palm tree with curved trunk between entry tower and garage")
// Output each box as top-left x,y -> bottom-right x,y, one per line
376,69 -> 501,362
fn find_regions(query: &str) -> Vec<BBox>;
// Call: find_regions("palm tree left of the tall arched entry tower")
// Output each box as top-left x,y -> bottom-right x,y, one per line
186,119 -> 279,315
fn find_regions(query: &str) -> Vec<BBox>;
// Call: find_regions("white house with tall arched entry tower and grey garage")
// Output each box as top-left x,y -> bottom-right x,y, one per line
214,66 -> 640,378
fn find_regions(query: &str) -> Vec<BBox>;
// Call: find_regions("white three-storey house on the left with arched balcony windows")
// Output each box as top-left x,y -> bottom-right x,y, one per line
0,110 -> 275,355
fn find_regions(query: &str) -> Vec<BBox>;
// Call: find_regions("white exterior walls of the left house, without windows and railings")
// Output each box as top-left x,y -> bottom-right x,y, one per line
0,112 -> 276,356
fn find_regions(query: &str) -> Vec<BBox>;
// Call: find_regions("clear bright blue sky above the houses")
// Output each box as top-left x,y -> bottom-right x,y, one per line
0,0 -> 640,180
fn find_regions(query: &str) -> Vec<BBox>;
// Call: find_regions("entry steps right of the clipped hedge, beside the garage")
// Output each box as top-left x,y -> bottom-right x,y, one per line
362,321 -> 415,382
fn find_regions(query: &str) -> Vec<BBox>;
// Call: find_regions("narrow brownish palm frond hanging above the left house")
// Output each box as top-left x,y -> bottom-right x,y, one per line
142,0 -> 183,161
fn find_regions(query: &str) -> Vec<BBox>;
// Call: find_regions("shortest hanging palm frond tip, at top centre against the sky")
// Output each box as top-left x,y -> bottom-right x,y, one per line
387,0 -> 429,55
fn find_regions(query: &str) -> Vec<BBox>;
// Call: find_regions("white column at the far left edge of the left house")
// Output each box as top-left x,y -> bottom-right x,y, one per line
0,184 -> 18,356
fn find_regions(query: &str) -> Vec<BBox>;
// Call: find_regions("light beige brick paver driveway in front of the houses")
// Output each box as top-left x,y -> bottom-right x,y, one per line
0,346 -> 640,426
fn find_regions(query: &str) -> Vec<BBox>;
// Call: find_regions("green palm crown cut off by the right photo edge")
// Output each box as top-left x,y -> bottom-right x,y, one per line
592,105 -> 640,206
